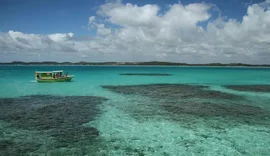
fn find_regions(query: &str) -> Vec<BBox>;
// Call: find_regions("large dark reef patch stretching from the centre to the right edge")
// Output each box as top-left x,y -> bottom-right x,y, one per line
103,84 -> 270,127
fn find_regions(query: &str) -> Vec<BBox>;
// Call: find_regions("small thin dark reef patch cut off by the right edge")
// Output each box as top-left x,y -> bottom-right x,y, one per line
224,85 -> 270,92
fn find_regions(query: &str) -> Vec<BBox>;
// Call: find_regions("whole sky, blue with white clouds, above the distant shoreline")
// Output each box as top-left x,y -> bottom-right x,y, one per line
0,0 -> 270,64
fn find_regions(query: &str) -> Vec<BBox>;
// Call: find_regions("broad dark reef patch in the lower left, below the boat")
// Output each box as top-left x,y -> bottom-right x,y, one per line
0,95 -> 107,154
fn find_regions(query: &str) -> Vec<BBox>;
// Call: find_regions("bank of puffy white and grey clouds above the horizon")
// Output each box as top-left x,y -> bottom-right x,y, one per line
0,0 -> 270,63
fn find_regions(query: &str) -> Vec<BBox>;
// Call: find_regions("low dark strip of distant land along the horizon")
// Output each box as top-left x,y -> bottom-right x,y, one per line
0,61 -> 270,67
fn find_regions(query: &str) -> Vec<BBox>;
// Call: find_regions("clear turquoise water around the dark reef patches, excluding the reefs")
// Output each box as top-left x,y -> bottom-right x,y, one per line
0,66 -> 270,156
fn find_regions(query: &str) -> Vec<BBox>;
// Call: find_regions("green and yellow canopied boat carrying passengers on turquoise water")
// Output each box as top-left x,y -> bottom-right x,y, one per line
35,70 -> 74,82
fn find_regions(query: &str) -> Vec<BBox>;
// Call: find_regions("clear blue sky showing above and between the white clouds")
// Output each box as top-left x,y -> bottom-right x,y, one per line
0,0 -> 262,36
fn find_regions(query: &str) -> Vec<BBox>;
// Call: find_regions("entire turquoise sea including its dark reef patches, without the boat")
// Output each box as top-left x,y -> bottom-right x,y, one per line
0,66 -> 270,156
